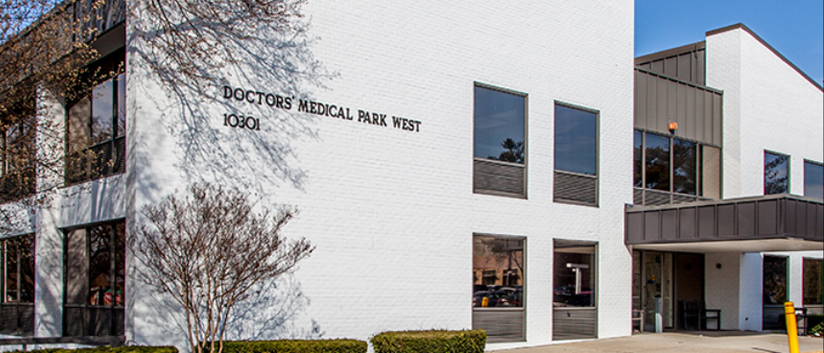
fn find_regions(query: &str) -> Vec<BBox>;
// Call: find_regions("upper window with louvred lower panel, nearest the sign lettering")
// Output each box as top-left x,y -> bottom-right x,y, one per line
473,84 -> 526,197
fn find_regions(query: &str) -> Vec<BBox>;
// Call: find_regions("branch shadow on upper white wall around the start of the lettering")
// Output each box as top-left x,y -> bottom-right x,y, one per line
129,11 -> 335,195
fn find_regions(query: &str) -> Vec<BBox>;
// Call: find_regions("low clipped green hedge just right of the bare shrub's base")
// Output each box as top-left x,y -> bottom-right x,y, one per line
217,339 -> 367,353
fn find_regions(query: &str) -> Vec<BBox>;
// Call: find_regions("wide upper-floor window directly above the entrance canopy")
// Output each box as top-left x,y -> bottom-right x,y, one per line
633,130 -> 721,205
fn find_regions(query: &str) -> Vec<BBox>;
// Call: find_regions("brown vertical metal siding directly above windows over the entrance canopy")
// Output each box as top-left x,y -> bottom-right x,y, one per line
634,69 -> 722,146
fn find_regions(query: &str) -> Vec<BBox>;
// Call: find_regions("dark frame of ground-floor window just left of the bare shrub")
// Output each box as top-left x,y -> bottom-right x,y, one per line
63,219 -> 127,337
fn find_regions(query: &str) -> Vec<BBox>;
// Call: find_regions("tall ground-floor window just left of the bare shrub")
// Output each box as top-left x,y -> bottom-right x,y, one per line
63,220 -> 126,336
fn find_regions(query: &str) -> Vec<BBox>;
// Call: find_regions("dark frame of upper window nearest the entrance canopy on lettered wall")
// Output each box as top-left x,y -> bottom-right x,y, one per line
552,100 -> 601,208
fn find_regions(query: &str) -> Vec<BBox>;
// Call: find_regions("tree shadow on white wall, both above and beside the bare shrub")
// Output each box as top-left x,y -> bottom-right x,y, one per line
126,2 -> 336,349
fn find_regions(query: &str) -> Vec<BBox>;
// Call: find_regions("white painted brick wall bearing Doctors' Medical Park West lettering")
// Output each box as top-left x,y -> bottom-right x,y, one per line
117,0 -> 633,348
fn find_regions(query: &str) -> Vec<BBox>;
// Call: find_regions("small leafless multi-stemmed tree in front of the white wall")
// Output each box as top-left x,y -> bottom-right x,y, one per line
132,183 -> 314,353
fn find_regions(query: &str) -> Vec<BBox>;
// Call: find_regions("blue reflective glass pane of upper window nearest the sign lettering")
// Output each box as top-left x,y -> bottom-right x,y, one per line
474,86 -> 526,164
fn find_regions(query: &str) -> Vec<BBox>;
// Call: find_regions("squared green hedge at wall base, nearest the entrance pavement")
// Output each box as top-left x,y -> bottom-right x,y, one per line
372,330 -> 486,353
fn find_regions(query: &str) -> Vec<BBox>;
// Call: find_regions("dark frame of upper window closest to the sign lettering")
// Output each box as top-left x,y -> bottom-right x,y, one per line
472,81 -> 529,199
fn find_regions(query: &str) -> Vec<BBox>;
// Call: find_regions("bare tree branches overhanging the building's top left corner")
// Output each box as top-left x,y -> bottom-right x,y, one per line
0,0 -> 315,234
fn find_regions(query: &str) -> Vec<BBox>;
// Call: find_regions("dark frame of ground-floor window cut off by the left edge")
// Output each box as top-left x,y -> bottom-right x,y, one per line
0,234 -> 37,336
